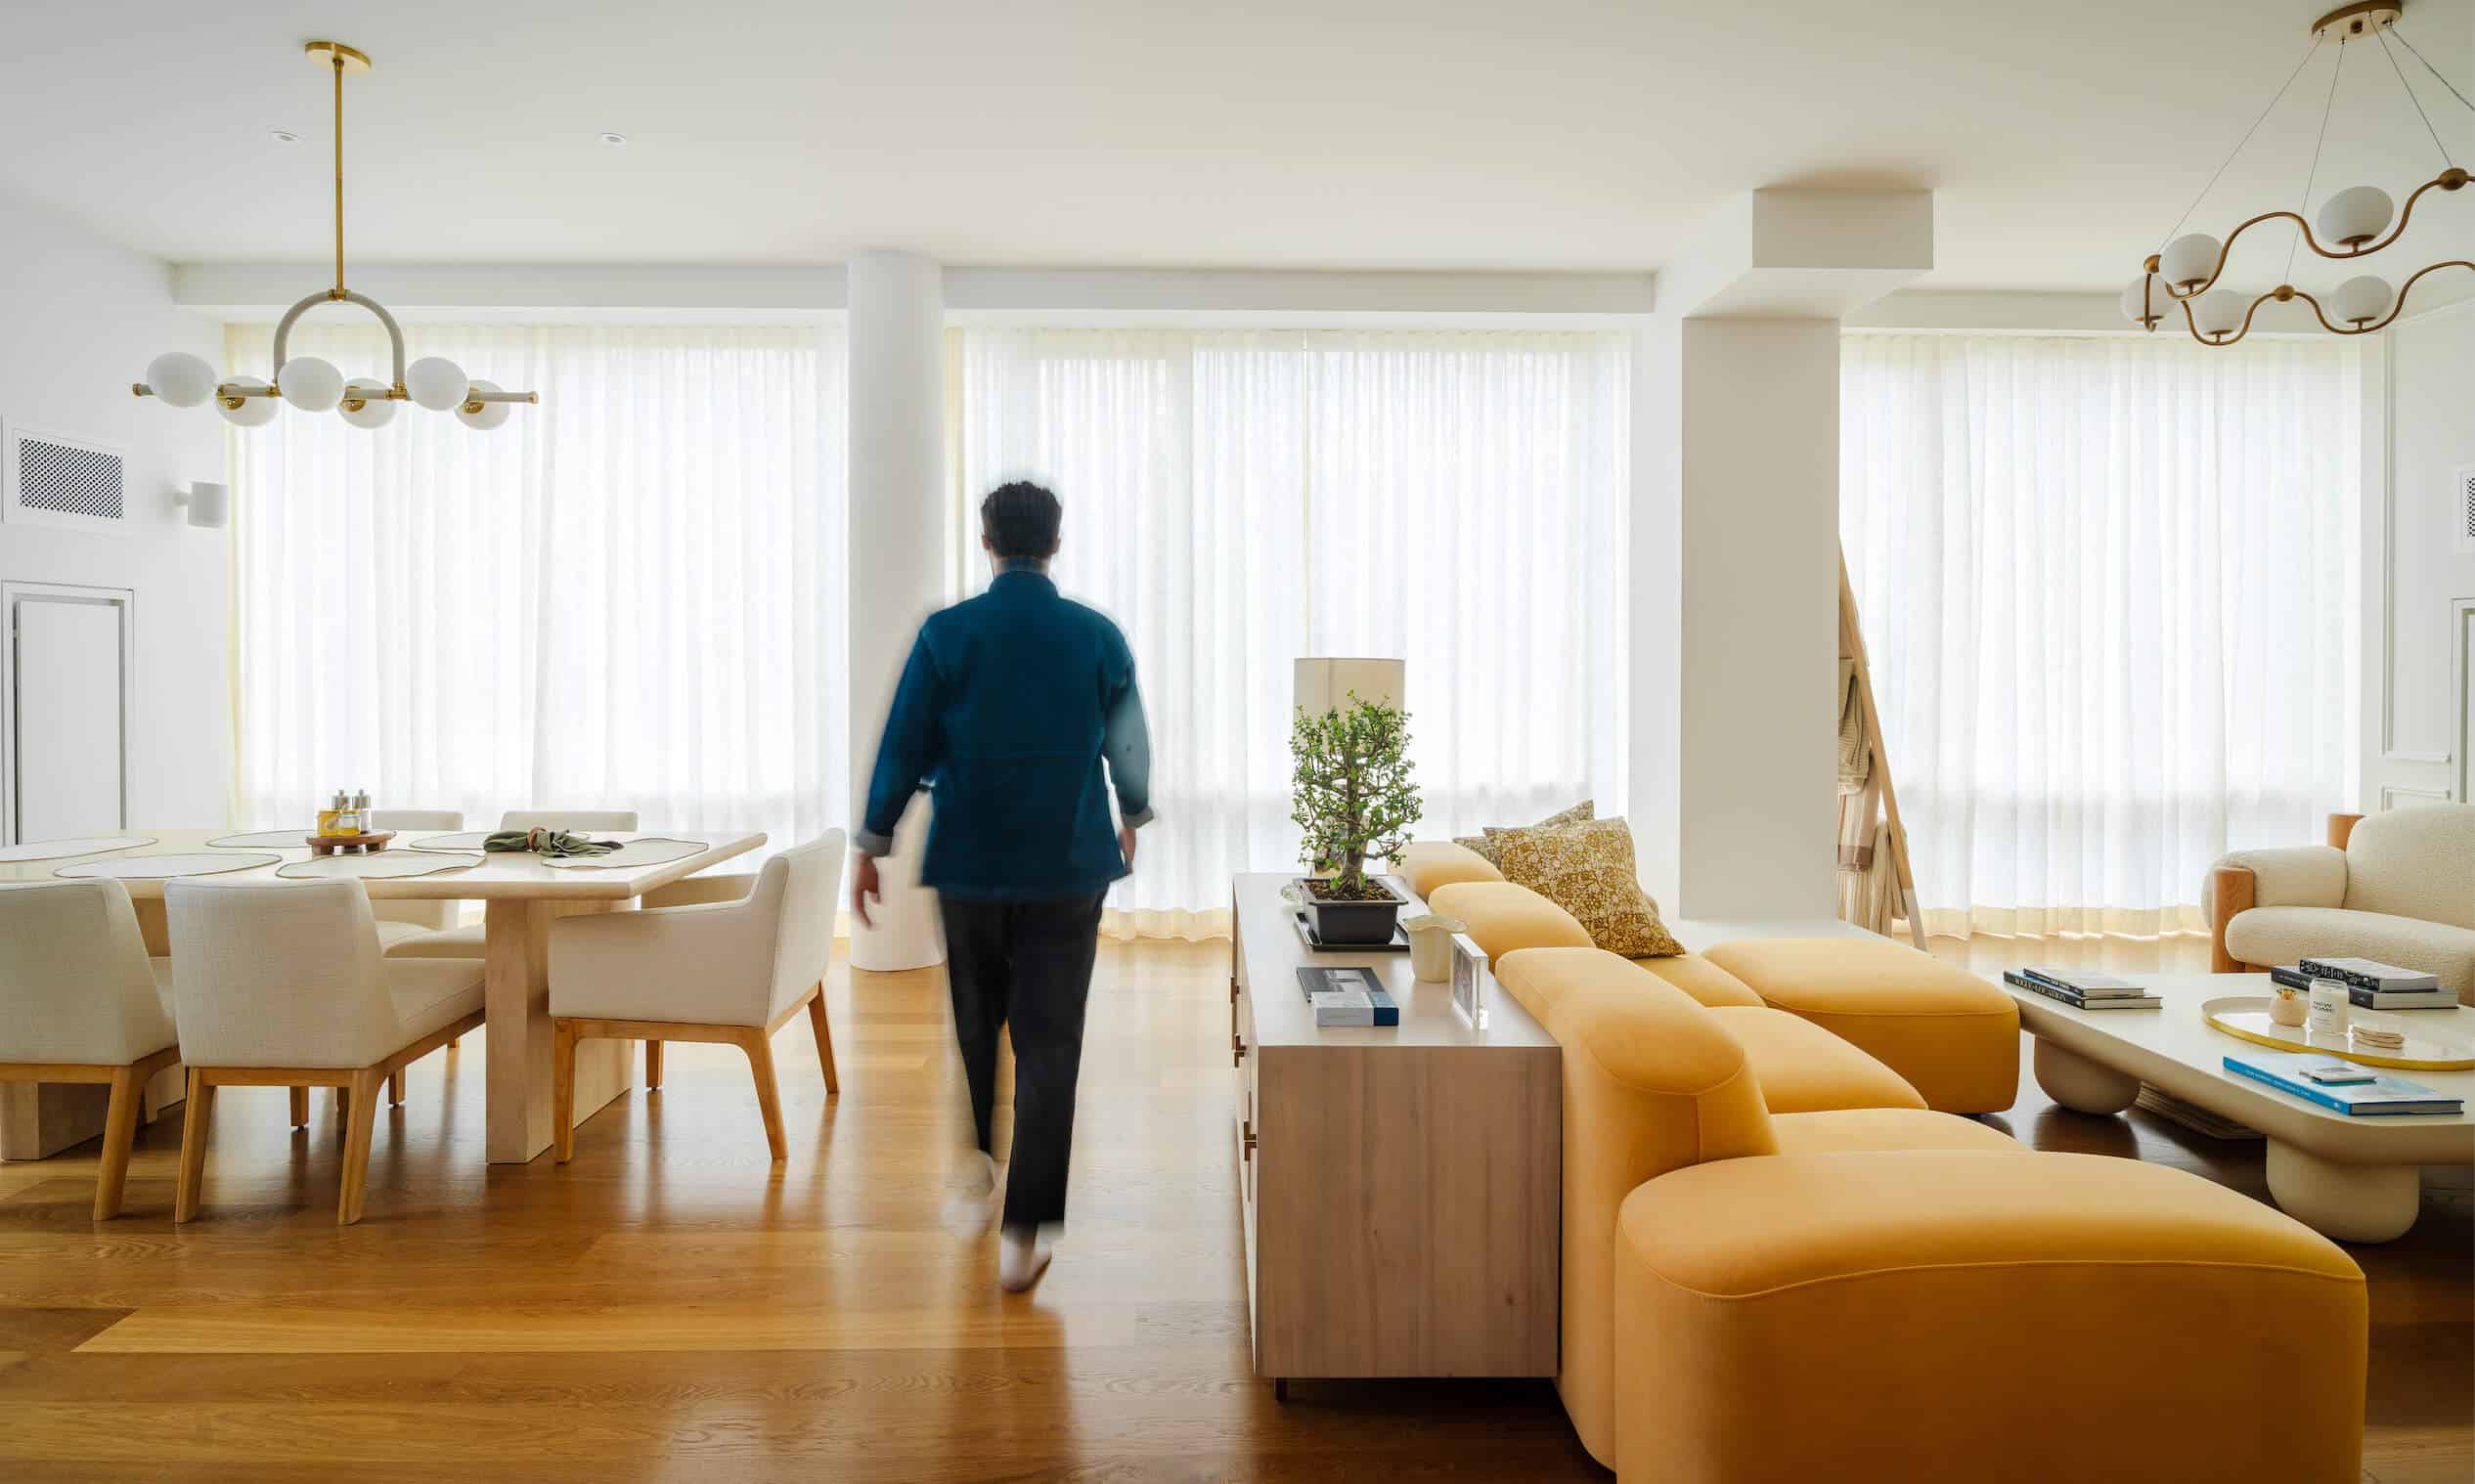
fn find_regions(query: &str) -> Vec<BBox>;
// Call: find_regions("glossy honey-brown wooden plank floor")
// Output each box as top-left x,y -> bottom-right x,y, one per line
0,939 -> 2475,1484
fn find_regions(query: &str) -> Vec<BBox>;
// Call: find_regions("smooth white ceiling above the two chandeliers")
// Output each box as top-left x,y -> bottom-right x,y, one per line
0,0 -> 2475,289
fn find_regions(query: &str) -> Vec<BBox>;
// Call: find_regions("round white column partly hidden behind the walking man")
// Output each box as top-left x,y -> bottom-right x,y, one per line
849,252 -> 946,970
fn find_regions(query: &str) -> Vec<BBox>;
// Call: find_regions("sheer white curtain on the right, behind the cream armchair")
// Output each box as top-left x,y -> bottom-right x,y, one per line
1839,334 -> 2362,933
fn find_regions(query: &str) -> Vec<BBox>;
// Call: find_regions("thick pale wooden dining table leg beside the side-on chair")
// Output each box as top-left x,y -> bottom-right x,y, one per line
483,900 -> 636,1165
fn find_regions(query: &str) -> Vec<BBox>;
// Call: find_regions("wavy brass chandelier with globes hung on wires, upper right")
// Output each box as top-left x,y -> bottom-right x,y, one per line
2121,0 -> 2475,346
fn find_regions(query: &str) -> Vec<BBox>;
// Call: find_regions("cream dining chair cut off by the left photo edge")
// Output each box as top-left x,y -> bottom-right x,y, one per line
0,881 -> 181,1222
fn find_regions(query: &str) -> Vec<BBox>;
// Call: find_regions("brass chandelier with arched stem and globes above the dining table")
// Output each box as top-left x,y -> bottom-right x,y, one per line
129,42 -> 542,430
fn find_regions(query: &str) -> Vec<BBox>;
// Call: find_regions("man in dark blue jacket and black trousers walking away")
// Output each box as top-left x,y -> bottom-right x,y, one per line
852,482 -> 1151,1293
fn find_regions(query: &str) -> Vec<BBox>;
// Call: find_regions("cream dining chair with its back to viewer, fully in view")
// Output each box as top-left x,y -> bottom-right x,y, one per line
163,878 -> 483,1227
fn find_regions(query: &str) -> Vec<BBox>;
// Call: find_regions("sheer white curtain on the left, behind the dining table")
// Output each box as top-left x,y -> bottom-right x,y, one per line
228,324 -> 849,844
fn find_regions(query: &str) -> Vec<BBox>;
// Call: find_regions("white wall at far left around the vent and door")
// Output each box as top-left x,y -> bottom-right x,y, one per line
0,193 -> 233,829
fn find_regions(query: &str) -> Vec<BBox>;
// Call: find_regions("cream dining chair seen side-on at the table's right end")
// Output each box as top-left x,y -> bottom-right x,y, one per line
550,829 -> 844,1165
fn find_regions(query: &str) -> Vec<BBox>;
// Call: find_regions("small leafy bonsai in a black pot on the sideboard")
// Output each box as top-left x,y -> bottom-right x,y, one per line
1290,690 -> 1418,944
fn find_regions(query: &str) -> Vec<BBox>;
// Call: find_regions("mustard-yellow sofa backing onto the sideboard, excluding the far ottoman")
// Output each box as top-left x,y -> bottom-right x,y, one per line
1401,849 -> 2368,1484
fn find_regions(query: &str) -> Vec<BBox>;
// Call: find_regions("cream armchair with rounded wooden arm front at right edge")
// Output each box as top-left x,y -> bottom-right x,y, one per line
2200,804 -> 2475,1004
